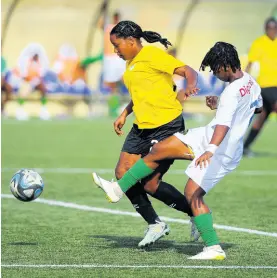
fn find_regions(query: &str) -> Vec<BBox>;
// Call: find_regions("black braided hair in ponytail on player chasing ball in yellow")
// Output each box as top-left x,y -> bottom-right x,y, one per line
110,20 -> 171,48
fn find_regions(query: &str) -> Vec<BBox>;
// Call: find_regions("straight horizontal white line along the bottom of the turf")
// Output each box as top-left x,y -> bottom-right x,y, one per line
2,264 -> 277,270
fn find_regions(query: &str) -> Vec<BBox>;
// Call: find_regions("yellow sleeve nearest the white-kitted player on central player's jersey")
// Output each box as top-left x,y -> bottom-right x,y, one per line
150,48 -> 185,75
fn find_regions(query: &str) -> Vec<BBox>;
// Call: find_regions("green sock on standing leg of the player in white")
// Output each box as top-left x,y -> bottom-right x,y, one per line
194,213 -> 219,246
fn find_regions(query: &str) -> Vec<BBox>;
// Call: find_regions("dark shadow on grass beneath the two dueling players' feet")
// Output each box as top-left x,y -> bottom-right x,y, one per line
88,235 -> 235,255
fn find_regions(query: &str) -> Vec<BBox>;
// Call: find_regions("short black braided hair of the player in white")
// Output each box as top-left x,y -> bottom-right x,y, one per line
200,42 -> 241,73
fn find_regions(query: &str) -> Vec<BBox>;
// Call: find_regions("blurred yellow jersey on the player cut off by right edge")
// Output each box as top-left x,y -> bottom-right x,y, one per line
248,35 -> 277,88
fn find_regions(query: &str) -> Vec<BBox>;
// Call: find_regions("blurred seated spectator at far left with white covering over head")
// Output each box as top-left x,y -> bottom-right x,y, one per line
7,43 -> 50,120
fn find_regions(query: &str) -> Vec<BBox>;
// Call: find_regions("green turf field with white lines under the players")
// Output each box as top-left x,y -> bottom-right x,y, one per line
1,116 -> 277,278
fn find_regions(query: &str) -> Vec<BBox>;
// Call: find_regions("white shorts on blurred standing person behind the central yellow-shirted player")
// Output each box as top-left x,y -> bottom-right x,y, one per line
103,55 -> 126,83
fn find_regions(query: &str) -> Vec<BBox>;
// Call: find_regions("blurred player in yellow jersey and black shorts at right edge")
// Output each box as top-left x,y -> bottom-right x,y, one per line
244,18 -> 277,156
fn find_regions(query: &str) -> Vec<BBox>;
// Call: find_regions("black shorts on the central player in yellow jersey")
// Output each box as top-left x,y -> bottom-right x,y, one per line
121,114 -> 185,157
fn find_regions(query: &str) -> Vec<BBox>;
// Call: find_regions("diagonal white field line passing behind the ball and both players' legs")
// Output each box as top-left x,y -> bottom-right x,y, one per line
1,194 -> 277,237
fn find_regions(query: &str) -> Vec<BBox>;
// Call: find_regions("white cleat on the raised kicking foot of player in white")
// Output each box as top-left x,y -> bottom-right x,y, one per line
92,173 -> 124,203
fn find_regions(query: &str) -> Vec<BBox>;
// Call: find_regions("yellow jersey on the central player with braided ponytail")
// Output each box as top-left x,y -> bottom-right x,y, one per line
123,46 -> 185,129
